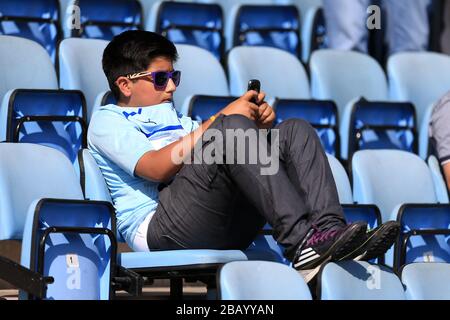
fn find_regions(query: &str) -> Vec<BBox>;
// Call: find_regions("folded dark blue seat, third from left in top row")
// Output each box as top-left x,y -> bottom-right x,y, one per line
146,1 -> 225,60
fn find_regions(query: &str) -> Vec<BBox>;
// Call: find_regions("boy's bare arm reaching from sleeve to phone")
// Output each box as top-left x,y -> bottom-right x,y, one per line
134,91 -> 264,182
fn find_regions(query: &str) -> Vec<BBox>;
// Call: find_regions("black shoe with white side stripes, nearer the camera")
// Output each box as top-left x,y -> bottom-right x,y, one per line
292,222 -> 367,271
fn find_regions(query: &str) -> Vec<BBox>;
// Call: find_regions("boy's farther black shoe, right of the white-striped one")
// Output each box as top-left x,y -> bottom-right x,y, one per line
341,221 -> 400,261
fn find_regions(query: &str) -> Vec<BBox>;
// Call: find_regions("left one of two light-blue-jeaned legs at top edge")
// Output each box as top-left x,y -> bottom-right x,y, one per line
323,0 -> 369,53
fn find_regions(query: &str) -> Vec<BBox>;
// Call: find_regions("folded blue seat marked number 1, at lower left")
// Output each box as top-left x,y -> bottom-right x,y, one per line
0,143 -> 142,300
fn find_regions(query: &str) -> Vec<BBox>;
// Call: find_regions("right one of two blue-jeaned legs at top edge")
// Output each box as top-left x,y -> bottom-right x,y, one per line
385,0 -> 430,55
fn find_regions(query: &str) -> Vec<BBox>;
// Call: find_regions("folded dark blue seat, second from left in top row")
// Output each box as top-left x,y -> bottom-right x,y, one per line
69,0 -> 142,40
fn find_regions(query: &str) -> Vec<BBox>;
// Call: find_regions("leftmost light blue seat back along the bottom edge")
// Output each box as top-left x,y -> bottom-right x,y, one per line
218,261 -> 312,300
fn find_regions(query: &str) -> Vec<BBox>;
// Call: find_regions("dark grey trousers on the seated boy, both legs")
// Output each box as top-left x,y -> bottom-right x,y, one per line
147,115 -> 345,258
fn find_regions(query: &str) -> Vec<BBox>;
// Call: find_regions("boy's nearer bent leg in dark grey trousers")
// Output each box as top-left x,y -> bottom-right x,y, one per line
148,115 -> 311,251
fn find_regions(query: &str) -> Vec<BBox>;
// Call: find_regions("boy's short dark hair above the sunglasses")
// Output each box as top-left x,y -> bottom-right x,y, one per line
102,30 -> 178,100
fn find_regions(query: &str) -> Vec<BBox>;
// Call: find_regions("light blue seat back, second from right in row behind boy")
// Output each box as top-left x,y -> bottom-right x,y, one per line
310,49 -> 388,114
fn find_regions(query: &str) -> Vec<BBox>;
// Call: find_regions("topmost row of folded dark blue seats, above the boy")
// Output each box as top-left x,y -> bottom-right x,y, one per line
0,0 -> 325,62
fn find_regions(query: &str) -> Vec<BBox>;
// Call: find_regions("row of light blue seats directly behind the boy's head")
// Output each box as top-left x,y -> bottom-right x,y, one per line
0,36 -> 450,166
